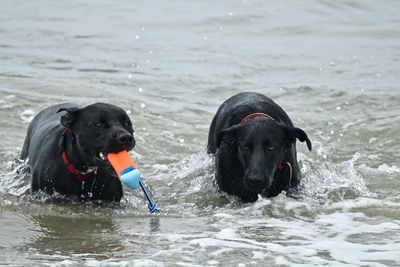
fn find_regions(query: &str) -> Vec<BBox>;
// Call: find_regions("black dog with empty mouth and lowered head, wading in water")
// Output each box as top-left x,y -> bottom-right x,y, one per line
208,92 -> 311,202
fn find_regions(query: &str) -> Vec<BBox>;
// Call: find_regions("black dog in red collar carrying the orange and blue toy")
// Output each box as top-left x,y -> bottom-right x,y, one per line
21,103 -> 135,201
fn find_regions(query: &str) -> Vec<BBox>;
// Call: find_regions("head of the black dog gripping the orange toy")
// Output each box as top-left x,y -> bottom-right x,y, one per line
58,103 -> 135,168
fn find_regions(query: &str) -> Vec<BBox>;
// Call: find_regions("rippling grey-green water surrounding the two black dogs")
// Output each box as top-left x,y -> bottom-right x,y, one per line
0,0 -> 400,266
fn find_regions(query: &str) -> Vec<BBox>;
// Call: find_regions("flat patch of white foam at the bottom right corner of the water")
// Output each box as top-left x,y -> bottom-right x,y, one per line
138,209 -> 400,266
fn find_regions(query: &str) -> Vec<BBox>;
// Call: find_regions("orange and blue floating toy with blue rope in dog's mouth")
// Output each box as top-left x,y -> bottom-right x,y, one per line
107,150 -> 159,213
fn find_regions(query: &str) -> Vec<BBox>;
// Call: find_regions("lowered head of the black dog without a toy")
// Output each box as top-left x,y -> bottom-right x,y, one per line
217,118 -> 311,193
